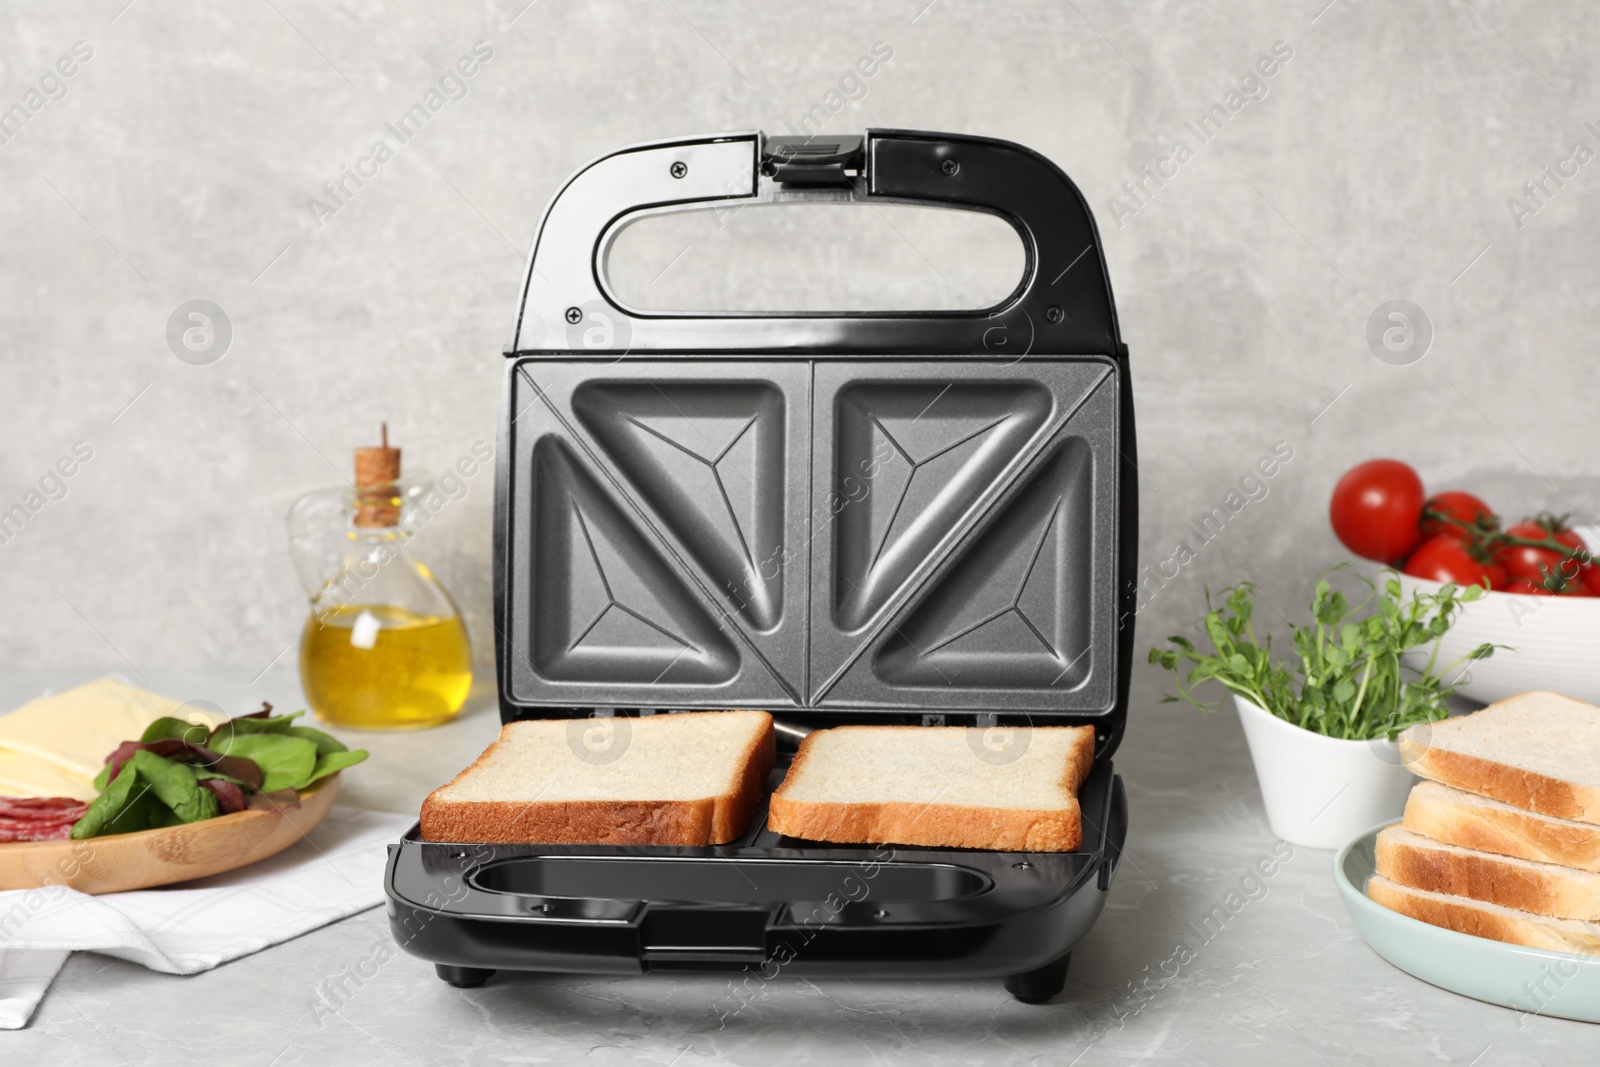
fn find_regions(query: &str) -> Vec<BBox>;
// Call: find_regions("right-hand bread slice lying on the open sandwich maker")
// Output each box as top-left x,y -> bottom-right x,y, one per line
766,726 -> 1094,853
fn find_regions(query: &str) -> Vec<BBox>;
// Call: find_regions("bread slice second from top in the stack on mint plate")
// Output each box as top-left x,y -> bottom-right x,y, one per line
1403,782 -> 1600,872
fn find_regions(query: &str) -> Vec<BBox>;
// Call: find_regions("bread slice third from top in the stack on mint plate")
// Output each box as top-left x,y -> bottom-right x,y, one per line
1378,825 -> 1600,923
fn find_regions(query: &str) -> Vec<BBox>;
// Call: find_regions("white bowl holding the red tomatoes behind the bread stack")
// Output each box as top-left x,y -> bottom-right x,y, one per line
1400,574 -> 1600,704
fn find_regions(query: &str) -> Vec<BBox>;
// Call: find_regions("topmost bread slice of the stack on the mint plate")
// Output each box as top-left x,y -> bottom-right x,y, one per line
1400,693 -> 1600,824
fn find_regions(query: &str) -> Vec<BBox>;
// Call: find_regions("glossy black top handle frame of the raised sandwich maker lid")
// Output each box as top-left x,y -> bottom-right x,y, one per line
507,130 -> 1125,360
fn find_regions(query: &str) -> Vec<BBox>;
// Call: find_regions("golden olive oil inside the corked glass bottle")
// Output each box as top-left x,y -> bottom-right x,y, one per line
301,605 -> 472,729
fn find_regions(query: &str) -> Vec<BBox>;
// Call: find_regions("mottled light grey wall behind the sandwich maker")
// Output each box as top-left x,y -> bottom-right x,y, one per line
0,0 -> 1600,673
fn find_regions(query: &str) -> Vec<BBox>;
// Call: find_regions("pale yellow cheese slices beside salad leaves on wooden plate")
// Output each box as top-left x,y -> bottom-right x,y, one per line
0,678 -> 221,779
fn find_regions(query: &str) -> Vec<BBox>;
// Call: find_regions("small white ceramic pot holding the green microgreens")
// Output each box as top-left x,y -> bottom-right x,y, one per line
1234,696 -> 1416,848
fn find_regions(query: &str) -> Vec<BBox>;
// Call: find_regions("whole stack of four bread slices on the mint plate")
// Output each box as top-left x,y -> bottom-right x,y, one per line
1366,693 -> 1600,955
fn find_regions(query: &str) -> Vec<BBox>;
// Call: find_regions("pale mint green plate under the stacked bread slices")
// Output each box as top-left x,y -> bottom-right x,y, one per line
1333,824 -> 1600,1022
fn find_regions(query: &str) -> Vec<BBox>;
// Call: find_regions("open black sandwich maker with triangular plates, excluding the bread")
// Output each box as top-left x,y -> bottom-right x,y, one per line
386,130 -> 1138,1001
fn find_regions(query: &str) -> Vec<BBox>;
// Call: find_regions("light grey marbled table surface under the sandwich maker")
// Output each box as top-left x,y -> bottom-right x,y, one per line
0,665 -> 1600,1067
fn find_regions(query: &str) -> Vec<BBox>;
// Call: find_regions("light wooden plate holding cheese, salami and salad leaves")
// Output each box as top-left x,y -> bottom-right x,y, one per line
0,774 -> 339,893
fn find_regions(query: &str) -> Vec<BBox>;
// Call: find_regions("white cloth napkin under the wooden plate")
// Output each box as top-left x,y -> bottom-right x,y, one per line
0,805 -> 416,1030
